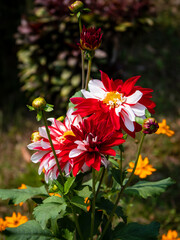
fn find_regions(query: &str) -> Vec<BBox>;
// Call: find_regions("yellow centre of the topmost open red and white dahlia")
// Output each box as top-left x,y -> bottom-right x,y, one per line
103,91 -> 126,108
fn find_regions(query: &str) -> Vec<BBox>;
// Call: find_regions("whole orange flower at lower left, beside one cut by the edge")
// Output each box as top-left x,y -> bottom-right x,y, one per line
5,212 -> 28,228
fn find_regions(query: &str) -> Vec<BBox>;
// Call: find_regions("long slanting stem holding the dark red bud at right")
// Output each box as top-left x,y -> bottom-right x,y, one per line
99,133 -> 145,240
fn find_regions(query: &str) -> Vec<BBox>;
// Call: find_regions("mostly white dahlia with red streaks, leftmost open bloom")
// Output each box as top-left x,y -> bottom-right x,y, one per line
27,108 -> 82,182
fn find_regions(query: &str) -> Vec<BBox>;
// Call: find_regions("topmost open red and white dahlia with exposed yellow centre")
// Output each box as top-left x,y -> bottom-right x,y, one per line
71,72 -> 155,137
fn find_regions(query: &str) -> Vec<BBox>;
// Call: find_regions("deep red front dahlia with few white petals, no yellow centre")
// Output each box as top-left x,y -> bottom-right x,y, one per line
59,117 -> 125,176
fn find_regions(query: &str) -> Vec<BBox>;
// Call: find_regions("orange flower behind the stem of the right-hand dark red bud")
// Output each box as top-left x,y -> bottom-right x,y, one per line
127,155 -> 156,178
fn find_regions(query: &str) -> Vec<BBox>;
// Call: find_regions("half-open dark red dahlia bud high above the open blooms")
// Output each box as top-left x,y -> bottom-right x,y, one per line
79,26 -> 103,51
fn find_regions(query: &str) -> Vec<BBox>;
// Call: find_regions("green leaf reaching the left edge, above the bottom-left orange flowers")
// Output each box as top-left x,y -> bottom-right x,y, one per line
0,186 -> 49,204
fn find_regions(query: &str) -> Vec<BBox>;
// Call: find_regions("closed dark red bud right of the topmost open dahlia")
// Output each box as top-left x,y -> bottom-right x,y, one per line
142,118 -> 159,134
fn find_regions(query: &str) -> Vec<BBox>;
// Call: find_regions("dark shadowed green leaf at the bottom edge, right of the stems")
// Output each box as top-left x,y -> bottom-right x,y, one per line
113,222 -> 160,240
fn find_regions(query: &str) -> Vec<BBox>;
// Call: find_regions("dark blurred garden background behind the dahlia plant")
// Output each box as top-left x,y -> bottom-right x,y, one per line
0,0 -> 180,236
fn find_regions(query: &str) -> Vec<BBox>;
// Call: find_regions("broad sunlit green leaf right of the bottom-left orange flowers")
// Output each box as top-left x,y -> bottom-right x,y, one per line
33,196 -> 67,229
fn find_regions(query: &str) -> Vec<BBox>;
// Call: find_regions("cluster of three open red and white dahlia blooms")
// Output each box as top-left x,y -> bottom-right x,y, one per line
28,69 -> 155,182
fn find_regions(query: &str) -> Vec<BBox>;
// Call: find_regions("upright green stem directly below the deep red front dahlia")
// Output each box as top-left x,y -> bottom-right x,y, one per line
91,168 -> 96,240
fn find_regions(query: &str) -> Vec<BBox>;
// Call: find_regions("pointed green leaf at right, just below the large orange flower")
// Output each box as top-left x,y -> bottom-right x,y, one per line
125,178 -> 175,198
